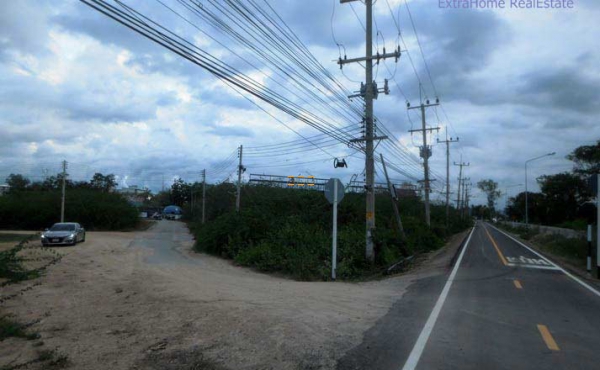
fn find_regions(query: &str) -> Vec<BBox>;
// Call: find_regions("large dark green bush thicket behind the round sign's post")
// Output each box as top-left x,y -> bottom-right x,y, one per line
186,183 -> 471,280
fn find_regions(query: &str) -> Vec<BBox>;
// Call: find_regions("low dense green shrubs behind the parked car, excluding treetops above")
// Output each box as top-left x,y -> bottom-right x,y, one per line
0,189 -> 138,230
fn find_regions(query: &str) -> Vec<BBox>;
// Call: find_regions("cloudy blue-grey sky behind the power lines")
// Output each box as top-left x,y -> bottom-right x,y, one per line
0,0 -> 600,206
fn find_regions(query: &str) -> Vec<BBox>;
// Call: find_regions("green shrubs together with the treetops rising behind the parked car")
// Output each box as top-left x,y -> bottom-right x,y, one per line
0,174 -> 138,230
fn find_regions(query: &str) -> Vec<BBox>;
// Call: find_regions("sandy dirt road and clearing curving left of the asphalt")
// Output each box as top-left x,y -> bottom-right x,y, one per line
0,221 -> 462,370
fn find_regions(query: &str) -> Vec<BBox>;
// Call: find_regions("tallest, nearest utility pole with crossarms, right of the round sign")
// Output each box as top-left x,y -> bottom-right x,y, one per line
338,0 -> 400,262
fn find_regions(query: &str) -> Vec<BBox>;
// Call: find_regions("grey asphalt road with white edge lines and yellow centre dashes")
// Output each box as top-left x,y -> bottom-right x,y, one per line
338,223 -> 600,370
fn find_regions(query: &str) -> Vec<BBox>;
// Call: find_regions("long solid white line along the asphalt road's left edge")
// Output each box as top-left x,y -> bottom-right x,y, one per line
402,227 -> 475,370
